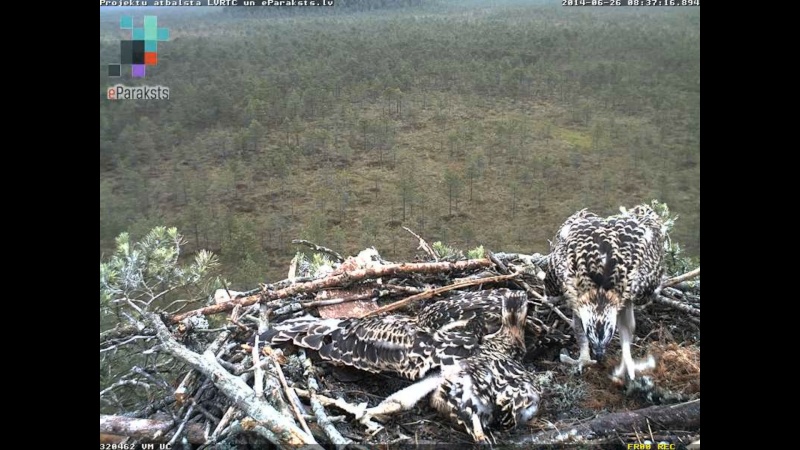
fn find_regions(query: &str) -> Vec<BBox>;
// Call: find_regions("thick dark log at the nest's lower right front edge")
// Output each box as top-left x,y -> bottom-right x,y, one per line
513,399 -> 700,445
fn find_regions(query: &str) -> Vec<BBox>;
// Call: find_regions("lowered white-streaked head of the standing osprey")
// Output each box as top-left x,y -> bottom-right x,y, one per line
577,289 -> 620,361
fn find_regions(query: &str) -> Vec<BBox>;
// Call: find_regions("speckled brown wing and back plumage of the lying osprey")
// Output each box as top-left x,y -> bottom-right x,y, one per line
260,289 -> 543,380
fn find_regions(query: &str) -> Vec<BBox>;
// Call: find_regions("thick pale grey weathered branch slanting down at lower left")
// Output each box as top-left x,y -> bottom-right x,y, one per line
145,313 -> 316,446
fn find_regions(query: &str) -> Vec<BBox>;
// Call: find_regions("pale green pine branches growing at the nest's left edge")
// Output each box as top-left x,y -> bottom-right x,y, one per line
100,227 -> 221,413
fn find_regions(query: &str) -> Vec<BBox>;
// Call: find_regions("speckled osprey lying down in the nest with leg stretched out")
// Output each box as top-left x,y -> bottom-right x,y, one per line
262,289 -> 539,442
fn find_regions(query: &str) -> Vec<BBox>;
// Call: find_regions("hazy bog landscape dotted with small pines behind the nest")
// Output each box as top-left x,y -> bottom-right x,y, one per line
100,0 -> 700,289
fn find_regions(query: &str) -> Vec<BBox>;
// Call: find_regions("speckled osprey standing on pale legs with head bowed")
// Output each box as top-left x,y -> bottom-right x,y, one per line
545,206 -> 665,379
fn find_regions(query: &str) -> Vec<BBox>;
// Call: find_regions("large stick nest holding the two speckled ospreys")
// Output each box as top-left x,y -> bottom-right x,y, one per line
100,240 -> 700,448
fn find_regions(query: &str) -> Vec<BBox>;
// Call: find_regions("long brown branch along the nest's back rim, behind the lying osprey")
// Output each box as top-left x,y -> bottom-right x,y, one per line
170,258 -> 492,323
